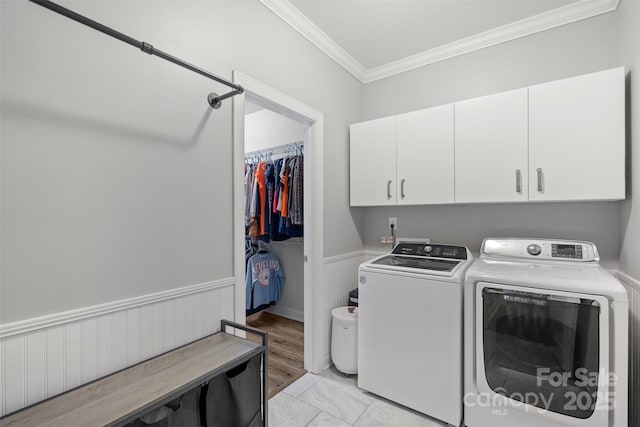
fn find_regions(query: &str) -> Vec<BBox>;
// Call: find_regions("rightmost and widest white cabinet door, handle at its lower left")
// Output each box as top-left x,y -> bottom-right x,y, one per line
529,68 -> 625,200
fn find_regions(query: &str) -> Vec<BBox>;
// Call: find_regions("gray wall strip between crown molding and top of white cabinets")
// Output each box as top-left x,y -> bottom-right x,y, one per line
363,13 -> 617,120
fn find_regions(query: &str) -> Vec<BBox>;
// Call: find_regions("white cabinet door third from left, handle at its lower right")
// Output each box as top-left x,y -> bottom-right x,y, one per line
455,88 -> 528,203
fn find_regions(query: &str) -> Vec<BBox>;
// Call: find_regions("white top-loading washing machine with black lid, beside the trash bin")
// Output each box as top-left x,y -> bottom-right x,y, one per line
358,241 -> 473,426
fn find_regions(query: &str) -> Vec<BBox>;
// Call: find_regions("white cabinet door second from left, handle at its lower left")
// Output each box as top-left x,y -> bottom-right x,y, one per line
397,104 -> 454,205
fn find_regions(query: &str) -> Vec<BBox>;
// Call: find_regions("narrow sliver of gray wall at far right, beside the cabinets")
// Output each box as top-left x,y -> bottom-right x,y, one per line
616,0 -> 640,279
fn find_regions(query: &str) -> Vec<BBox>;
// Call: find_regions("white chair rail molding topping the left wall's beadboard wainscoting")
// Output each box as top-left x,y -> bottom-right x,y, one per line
0,277 -> 235,339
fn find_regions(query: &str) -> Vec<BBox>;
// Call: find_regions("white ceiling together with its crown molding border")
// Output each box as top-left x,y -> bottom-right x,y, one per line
260,0 -> 620,83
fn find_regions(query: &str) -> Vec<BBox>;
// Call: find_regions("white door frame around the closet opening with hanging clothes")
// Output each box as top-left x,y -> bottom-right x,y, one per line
233,71 -> 324,373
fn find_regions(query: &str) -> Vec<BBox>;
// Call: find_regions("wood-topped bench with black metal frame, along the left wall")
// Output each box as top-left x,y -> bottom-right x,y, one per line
0,320 -> 268,427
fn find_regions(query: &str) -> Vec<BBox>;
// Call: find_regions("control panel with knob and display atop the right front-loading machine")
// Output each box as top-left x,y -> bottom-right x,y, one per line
481,237 -> 600,262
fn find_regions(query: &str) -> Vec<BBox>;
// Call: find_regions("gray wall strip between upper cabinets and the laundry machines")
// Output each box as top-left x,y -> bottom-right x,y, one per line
364,202 -> 618,268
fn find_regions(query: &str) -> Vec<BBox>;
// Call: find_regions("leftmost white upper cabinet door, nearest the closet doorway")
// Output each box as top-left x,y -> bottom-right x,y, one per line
349,116 -> 396,206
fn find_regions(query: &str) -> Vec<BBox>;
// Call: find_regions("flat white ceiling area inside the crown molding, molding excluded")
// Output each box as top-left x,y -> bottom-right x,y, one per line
291,0 -> 576,69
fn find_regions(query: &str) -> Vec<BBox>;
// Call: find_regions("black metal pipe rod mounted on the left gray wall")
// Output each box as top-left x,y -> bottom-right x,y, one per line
29,0 -> 244,109
